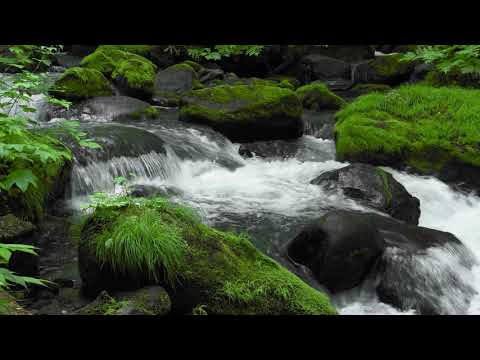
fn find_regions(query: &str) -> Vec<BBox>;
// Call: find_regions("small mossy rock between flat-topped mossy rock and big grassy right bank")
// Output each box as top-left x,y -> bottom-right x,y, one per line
295,83 -> 345,111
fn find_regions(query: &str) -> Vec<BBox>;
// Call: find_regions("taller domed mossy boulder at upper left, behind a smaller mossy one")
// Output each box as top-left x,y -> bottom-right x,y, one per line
80,45 -> 157,99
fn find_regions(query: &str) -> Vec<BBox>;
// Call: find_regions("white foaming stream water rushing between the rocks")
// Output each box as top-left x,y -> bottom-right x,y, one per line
66,116 -> 480,314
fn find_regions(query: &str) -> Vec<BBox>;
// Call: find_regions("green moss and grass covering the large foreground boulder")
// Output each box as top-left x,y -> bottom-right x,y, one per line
83,198 -> 336,314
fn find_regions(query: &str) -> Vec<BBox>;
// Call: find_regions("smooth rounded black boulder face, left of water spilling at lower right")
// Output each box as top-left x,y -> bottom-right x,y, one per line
288,211 -> 385,293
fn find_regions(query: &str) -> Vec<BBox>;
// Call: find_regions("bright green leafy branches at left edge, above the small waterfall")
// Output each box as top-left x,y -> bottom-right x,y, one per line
0,45 -> 99,193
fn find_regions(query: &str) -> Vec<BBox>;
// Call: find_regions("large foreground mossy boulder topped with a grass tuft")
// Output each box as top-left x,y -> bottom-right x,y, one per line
79,198 -> 336,314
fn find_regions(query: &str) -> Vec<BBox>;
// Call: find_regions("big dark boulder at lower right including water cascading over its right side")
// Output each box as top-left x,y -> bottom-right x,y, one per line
287,210 -> 475,314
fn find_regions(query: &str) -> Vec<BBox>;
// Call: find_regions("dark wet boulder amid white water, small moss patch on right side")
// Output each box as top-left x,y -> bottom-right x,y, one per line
310,163 -> 420,225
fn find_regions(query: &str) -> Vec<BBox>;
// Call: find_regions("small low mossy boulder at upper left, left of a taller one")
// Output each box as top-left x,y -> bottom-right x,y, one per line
52,67 -> 113,101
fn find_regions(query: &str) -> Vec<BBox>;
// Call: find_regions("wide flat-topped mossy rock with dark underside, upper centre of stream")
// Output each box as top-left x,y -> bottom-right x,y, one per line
180,85 -> 305,142
